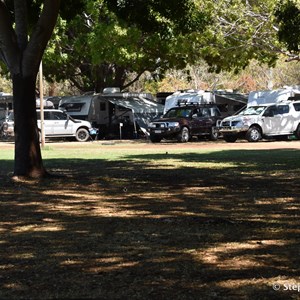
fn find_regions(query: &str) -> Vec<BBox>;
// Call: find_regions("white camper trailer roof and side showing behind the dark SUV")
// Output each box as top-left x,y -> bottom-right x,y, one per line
164,90 -> 247,117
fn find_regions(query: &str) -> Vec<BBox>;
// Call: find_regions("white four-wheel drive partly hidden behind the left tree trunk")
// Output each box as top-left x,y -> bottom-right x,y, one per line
2,109 -> 97,142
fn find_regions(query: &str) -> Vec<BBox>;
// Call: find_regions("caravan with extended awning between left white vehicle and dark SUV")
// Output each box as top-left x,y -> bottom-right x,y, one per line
59,90 -> 164,138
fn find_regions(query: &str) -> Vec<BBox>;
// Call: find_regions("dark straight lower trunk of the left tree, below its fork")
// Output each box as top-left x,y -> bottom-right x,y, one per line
13,75 -> 47,178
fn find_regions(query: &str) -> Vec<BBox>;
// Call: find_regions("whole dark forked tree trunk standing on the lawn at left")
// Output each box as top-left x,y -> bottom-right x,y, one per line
0,0 -> 60,177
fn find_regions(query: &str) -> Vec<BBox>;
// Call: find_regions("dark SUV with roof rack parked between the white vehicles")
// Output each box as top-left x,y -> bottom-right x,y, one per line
148,104 -> 221,143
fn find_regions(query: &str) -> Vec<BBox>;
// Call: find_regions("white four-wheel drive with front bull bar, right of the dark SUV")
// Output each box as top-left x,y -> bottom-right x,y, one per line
217,101 -> 300,143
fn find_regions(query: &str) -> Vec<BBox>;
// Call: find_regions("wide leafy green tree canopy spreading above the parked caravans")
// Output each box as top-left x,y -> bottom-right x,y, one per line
44,0 -> 298,92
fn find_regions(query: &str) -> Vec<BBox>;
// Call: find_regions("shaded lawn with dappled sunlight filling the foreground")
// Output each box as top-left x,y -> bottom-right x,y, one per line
0,144 -> 300,299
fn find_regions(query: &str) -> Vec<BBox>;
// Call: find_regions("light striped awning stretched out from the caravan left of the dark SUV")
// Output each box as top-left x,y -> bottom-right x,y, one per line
104,96 -> 164,130
